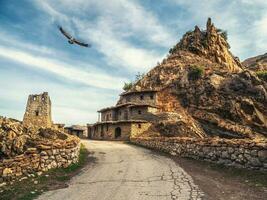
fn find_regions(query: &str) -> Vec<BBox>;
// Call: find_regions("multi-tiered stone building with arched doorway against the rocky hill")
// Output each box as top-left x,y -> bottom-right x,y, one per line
87,90 -> 158,140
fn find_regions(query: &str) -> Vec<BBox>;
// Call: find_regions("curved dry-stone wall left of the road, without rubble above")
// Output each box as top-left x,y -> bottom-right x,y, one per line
0,136 -> 80,183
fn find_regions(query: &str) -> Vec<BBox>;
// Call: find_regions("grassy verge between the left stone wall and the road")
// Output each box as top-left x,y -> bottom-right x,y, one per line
0,144 -> 88,200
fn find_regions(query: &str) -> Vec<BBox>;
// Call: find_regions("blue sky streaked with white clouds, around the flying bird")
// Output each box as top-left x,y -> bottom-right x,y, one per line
0,0 -> 267,125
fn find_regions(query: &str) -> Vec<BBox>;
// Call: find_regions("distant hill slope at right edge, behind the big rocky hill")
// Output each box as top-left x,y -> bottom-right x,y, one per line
242,53 -> 267,71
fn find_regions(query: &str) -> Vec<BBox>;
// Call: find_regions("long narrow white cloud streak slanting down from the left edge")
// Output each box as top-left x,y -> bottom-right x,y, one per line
0,45 -> 126,89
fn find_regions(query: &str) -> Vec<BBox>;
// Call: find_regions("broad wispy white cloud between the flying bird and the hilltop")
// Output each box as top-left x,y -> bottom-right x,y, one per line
33,0 -> 174,71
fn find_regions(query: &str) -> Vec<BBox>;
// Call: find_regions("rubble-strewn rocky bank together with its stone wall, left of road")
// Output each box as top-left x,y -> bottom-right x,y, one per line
0,117 -> 80,183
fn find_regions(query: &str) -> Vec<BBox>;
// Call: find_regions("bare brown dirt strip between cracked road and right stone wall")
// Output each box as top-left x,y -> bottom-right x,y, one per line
176,157 -> 267,200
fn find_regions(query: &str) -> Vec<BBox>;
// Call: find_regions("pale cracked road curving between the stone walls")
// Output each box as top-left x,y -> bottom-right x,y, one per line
38,140 -> 204,200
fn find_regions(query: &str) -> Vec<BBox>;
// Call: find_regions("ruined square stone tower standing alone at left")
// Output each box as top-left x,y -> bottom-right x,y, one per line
23,92 -> 52,127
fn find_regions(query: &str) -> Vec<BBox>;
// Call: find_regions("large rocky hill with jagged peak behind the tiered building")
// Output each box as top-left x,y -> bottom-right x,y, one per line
130,19 -> 267,139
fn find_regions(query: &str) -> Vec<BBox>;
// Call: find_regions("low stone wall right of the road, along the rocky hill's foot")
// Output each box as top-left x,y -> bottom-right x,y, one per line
131,137 -> 267,170
